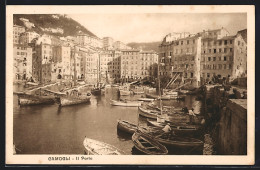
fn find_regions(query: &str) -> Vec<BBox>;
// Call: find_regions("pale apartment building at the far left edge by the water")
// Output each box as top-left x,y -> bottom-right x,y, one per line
13,44 -> 32,81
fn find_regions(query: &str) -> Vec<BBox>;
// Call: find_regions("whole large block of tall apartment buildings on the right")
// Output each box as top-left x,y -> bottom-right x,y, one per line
159,28 -> 246,87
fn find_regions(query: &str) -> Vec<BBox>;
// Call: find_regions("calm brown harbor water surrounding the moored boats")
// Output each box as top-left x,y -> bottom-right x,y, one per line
13,86 -> 213,155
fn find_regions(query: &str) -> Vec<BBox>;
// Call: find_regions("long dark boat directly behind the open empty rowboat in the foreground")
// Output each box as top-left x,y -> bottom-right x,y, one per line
143,132 -> 204,149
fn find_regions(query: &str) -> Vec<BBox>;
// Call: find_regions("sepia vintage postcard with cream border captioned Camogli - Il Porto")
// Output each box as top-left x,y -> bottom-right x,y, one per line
6,5 -> 255,165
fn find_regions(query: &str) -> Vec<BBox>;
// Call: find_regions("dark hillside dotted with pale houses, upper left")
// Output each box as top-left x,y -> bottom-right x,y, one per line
13,14 -> 97,37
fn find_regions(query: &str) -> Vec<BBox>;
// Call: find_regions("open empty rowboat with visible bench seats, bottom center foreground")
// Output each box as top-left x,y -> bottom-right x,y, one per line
132,131 -> 168,155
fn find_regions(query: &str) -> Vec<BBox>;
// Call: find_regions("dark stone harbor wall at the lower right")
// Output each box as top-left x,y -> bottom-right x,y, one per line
204,85 -> 247,155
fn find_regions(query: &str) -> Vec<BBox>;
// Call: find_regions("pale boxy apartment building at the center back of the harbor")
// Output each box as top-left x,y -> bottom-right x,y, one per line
121,50 -> 158,81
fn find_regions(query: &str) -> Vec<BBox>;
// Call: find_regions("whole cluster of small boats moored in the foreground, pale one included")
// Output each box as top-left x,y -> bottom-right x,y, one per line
83,96 -> 204,155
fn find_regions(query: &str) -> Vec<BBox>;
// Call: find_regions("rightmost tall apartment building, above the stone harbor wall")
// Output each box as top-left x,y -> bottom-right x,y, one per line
201,29 -> 247,80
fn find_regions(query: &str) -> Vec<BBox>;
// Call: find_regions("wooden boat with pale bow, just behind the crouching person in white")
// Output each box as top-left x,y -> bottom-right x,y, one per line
147,119 -> 200,134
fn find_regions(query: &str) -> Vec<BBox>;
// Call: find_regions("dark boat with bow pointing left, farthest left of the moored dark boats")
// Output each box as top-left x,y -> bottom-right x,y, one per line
117,120 -> 159,135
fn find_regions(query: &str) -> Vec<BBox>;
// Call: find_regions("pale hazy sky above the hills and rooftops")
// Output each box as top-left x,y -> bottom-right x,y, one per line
69,13 -> 247,43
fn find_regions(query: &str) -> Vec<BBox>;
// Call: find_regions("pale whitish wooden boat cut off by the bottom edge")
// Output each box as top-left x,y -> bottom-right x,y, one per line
83,137 -> 125,155
